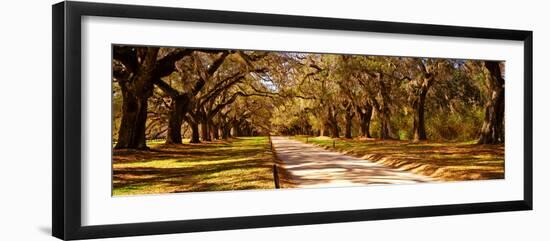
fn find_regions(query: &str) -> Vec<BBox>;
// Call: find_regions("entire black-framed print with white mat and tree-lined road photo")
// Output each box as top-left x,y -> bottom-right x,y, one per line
53,1 -> 532,239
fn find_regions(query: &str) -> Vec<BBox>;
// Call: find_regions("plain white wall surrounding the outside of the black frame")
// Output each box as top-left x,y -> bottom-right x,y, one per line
0,0 -> 550,241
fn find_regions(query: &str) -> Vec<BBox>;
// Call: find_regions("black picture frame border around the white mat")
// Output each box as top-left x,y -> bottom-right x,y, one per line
52,2 -> 533,240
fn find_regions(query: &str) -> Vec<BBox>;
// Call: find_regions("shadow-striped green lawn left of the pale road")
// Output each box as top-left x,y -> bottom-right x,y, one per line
113,137 -> 274,196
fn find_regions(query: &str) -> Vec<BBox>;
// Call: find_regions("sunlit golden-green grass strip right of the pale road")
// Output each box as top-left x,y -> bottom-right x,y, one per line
293,136 -> 504,181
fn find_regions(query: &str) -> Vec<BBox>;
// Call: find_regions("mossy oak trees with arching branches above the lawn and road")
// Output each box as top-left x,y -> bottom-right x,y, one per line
112,45 -> 504,149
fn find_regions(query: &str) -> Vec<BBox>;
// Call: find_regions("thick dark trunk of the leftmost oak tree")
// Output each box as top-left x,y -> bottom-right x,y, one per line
115,92 -> 148,149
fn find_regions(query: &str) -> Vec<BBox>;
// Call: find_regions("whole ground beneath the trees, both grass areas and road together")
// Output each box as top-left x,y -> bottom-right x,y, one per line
113,137 -> 504,196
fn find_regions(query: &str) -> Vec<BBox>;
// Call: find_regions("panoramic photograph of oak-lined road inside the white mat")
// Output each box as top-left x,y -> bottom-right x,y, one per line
111,44 -> 506,196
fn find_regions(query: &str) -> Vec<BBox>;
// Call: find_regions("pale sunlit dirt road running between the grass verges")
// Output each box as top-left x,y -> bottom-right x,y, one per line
271,137 -> 435,187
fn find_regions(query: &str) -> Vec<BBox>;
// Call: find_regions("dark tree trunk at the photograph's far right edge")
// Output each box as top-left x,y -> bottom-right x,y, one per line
478,61 -> 504,144
